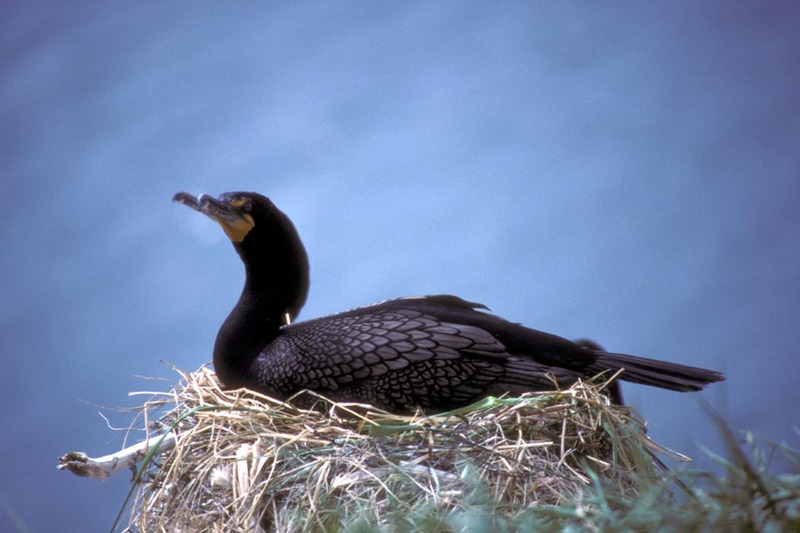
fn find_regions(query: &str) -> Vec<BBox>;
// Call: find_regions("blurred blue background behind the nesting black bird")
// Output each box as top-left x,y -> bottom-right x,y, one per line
0,1 -> 800,532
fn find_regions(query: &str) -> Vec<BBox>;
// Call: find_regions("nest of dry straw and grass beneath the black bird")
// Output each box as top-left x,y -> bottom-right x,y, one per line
130,367 -> 688,533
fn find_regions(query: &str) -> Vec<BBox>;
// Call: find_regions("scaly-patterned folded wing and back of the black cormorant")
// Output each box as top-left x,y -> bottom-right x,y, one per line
245,296 -> 636,411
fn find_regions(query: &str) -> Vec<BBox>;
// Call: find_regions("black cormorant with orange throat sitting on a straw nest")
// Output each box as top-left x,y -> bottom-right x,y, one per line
174,192 -> 724,412
